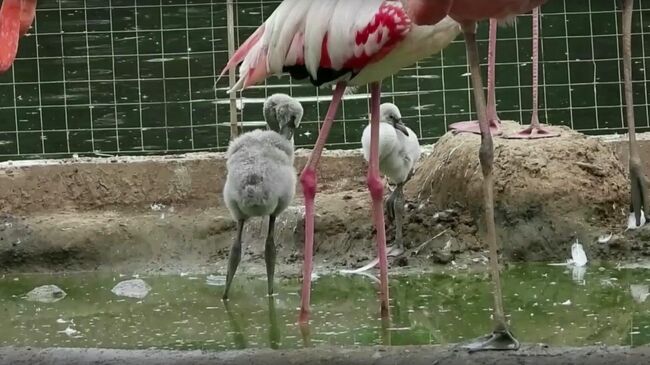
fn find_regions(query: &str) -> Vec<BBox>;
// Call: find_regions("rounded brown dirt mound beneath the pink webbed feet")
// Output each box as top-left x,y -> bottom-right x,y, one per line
407,122 -> 629,261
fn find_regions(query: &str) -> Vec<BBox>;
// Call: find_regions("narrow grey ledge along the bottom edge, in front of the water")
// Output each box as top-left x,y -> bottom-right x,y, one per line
0,345 -> 650,365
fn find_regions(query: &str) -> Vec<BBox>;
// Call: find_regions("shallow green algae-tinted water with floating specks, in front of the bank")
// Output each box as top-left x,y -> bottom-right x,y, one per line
0,264 -> 650,351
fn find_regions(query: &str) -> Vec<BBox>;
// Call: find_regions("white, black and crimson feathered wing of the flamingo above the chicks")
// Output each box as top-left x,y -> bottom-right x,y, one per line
221,0 -> 411,92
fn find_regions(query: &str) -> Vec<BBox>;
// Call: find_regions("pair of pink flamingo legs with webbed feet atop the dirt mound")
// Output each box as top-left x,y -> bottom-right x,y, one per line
449,7 -> 560,139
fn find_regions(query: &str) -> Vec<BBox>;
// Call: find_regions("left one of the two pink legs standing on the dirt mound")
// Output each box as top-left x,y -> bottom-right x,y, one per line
449,19 -> 502,136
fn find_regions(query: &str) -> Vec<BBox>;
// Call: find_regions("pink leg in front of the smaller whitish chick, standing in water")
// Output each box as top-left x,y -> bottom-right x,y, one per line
367,82 -> 389,318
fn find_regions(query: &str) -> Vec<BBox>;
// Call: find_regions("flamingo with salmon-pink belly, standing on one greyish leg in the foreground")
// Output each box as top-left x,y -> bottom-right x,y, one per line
412,0 -> 546,351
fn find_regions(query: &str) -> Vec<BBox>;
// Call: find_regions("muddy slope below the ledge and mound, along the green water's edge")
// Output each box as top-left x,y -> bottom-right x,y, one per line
0,178 -> 650,276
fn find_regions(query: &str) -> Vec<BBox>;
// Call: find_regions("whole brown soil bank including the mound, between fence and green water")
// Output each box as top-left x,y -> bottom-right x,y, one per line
0,122 -> 650,276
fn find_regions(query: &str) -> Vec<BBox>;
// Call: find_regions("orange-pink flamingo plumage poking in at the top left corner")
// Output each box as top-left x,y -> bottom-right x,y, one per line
0,0 -> 36,73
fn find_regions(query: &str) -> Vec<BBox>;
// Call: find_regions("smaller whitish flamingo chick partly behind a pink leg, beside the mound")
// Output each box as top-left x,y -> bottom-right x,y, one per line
361,103 -> 422,255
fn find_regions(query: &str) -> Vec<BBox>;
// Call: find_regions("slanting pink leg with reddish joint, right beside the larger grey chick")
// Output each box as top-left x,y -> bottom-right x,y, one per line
299,82 -> 346,324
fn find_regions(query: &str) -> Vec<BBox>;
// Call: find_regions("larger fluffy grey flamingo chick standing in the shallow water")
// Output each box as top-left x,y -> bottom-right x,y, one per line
223,94 -> 303,300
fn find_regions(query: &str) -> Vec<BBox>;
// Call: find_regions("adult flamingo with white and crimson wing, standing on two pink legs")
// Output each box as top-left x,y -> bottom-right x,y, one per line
220,0 -> 460,324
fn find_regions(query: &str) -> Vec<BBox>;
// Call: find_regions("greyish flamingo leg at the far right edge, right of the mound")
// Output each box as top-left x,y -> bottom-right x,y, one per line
622,0 -> 650,228
